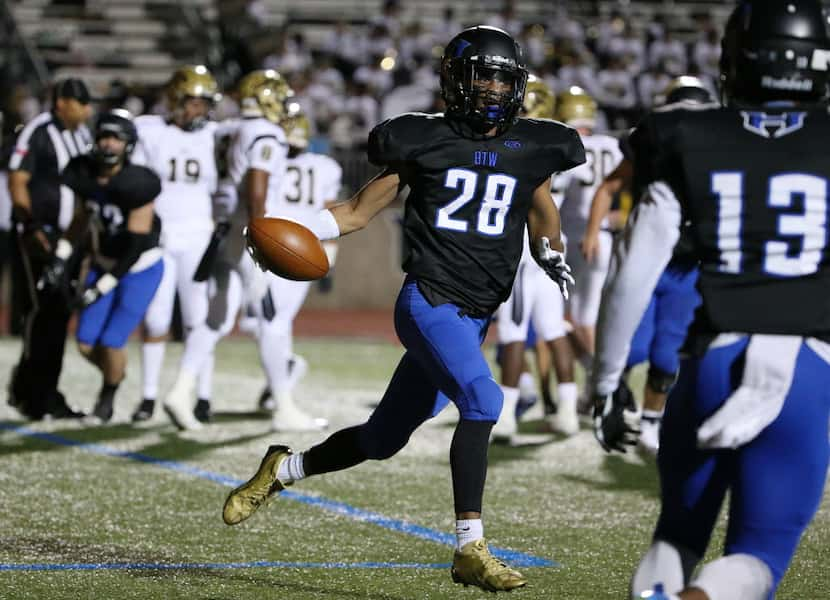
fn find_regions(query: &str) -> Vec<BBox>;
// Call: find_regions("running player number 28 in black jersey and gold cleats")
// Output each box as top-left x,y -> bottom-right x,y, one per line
223,27 -> 585,591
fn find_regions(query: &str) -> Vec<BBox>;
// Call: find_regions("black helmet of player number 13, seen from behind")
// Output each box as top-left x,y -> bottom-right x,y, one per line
720,0 -> 830,106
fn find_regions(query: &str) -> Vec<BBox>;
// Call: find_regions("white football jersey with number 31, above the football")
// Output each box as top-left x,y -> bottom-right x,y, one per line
269,152 -> 343,222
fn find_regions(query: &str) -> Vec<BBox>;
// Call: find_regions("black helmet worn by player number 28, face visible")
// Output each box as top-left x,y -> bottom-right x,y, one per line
441,25 -> 527,134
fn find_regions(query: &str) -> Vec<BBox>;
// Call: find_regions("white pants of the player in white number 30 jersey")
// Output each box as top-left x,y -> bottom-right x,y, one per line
567,231 -> 613,327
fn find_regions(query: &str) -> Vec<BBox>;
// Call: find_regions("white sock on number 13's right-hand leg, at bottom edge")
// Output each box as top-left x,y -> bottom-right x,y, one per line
689,554 -> 772,600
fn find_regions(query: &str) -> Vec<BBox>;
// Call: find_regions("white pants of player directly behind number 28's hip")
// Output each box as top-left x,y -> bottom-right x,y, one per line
497,261 -> 567,344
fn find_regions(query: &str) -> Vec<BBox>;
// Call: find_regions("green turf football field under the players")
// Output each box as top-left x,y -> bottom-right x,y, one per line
0,338 -> 830,600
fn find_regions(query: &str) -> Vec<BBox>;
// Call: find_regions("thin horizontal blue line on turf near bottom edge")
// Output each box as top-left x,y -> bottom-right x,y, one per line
0,560 -> 451,572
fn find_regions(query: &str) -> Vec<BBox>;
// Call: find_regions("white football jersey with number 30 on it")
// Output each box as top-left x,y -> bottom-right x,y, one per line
553,134 -> 622,241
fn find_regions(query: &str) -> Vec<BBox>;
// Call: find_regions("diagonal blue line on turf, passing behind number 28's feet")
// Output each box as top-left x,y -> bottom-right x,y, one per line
0,423 -> 559,567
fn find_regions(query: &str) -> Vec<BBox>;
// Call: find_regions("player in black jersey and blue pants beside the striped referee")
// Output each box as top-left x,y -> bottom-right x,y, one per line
42,109 -> 164,422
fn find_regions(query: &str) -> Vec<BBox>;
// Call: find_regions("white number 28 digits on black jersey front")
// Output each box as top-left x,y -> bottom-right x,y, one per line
435,169 -> 516,235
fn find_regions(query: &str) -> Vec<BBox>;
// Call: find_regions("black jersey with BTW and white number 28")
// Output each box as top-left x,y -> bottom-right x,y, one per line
369,113 -> 585,316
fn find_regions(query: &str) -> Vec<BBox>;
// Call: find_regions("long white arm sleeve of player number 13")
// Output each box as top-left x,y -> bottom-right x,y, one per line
592,182 -> 681,396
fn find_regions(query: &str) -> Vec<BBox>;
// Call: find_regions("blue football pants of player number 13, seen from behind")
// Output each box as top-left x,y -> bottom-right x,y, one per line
655,339 -> 830,586
